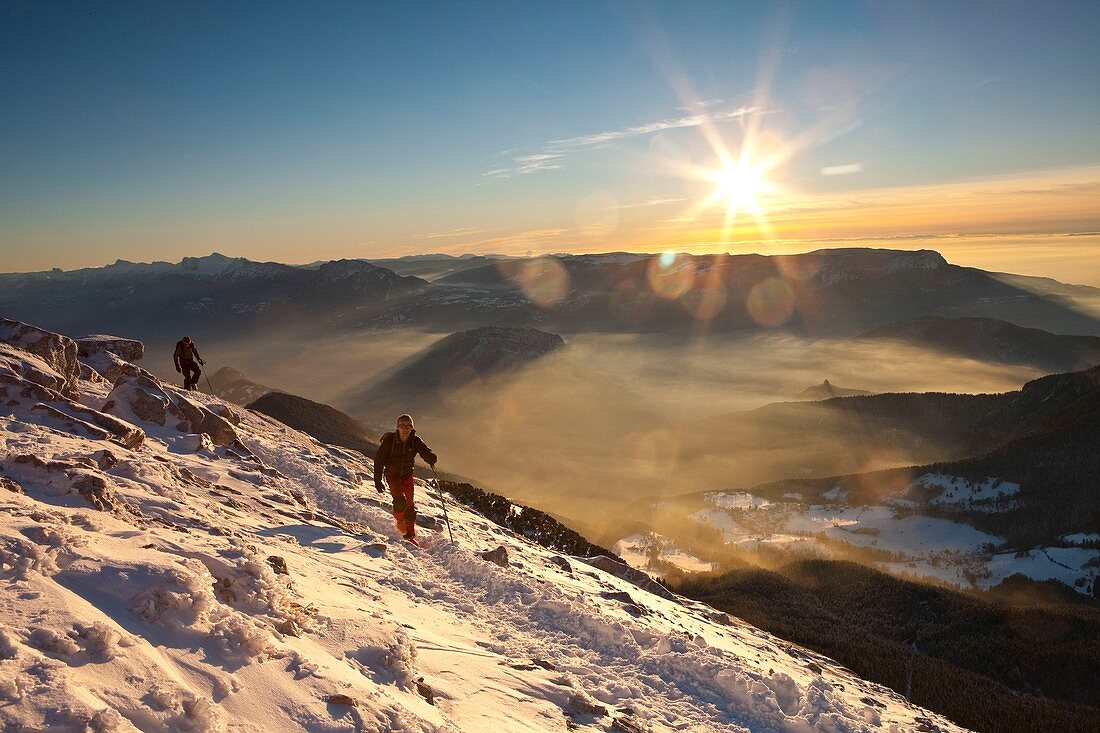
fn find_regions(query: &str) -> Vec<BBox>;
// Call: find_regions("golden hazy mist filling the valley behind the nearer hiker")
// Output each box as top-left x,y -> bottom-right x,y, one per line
200,330 -> 1040,537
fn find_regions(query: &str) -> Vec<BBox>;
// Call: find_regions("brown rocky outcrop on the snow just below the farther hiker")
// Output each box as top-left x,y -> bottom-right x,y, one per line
103,375 -> 242,447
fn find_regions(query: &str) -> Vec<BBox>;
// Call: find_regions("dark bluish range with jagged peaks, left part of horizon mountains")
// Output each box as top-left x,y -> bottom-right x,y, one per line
0,253 -> 428,341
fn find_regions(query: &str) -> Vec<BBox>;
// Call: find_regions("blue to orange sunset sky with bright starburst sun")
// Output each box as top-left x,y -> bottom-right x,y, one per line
0,0 -> 1100,284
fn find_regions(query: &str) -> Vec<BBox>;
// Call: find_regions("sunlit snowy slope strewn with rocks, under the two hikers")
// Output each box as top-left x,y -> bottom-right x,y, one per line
0,323 -> 958,733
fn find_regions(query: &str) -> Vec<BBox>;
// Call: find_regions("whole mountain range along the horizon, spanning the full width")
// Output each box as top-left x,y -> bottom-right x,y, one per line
0,249 -> 1100,346
